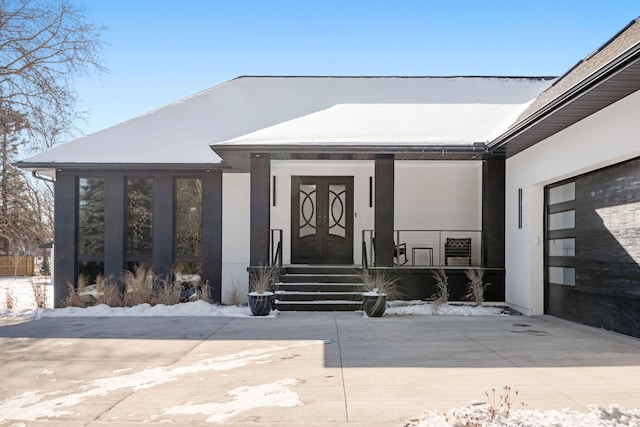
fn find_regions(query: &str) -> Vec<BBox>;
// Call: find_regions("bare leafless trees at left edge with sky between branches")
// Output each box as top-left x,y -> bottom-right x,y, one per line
0,0 -> 106,256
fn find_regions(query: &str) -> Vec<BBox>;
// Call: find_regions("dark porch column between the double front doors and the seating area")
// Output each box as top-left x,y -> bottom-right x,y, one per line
374,154 -> 395,267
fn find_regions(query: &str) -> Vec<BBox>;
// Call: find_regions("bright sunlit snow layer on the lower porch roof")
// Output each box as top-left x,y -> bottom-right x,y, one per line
217,103 -> 529,145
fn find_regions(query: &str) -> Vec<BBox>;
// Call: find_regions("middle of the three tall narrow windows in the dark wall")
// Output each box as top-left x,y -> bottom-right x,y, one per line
126,178 -> 153,271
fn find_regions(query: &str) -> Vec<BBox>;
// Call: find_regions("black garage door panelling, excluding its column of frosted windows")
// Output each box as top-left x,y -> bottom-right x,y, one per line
547,159 -> 640,337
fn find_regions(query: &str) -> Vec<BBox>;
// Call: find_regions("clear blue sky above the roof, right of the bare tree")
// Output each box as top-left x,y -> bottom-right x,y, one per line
71,0 -> 640,136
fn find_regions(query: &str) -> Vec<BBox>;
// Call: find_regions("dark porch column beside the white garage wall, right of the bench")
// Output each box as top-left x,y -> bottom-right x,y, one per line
482,158 -> 508,268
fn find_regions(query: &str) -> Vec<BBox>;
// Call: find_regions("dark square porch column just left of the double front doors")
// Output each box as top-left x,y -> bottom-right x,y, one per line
249,154 -> 271,266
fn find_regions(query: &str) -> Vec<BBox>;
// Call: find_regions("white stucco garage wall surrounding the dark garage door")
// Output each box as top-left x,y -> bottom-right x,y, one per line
506,91 -> 640,315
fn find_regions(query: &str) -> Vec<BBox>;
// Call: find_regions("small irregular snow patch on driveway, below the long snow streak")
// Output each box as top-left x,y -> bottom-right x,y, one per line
164,379 -> 302,423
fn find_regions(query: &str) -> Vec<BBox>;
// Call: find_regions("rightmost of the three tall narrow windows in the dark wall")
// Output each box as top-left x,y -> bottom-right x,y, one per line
174,178 -> 202,282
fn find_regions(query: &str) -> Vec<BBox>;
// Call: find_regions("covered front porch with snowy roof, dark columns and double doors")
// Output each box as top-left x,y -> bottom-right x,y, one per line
212,103 -> 521,308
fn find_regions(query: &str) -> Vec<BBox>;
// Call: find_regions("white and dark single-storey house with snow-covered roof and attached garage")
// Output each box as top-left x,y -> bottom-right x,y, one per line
18,16 -> 640,336
